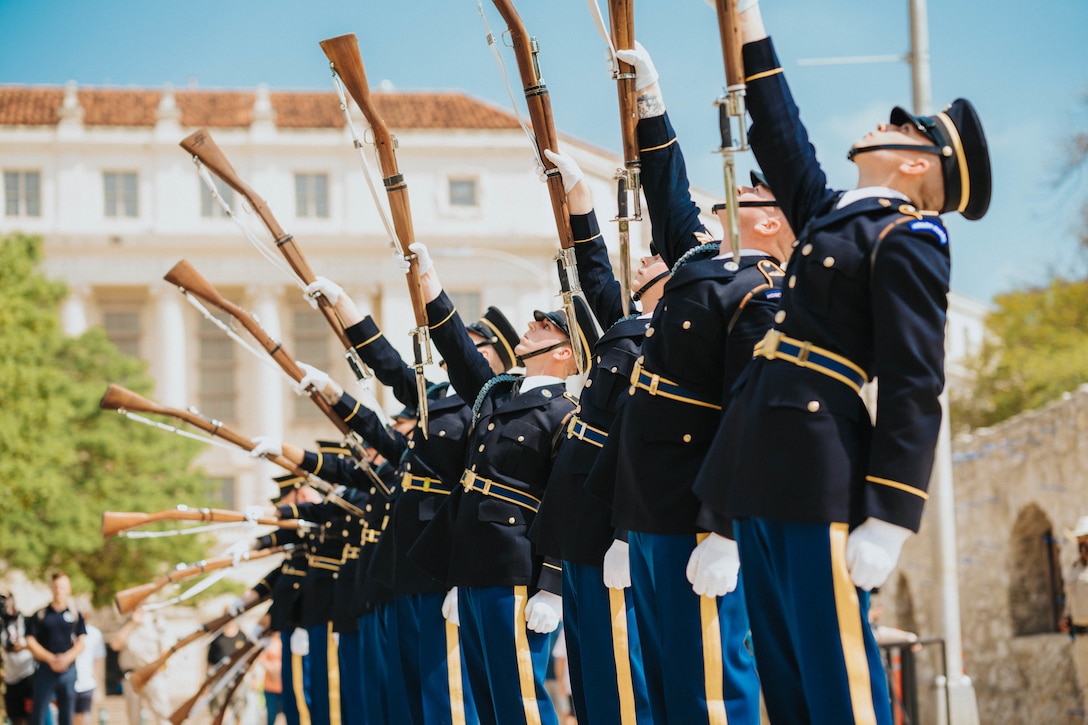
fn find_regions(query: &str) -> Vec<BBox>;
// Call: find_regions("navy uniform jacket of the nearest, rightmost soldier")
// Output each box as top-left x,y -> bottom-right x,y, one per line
696,39 -> 950,531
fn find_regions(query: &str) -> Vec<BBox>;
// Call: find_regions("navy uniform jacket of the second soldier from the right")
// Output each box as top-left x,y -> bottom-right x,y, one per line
588,116 -> 781,534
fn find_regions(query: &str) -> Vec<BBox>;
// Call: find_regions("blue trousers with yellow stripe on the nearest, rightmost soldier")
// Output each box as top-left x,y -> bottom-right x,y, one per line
735,518 -> 892,725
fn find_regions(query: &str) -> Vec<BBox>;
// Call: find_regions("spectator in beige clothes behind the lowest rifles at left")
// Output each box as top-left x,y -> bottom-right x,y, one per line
110,606 -> 171,725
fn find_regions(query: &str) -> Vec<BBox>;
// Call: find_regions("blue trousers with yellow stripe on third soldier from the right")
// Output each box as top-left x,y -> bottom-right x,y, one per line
562,562 -> 653,725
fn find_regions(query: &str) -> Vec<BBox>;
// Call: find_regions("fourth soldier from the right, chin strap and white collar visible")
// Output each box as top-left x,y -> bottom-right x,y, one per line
410,243 -> 592,725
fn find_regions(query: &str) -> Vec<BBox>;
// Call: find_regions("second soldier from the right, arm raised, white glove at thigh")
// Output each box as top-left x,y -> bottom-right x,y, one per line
588,46 -> 793,723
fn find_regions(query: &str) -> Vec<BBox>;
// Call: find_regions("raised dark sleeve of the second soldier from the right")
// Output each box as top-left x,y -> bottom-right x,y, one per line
636,113 -> 710,268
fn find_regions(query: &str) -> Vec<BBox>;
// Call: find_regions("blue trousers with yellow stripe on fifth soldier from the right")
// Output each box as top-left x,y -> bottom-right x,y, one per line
393,593 -> 480,725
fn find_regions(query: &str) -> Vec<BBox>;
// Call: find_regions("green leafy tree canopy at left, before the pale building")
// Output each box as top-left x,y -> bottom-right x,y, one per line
0,234 -> 216,604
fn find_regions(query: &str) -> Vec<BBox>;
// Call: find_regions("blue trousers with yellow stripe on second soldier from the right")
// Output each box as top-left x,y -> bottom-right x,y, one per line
628,524 -> 757,725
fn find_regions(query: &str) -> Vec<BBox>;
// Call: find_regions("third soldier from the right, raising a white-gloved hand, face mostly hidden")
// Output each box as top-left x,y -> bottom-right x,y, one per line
530,150 -> 652,724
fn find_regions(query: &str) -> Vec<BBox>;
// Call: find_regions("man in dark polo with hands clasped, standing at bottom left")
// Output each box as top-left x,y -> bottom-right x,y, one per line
26,572 -> 87,725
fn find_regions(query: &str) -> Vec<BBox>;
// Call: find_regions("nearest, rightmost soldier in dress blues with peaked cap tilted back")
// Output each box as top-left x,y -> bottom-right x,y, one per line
696,2 -> 990,724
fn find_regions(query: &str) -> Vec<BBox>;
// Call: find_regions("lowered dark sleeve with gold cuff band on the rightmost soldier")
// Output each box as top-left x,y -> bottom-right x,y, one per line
865,219 -> 951,531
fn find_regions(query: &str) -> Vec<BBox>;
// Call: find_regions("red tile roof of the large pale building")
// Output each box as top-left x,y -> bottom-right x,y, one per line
0,86 -> 518,128
